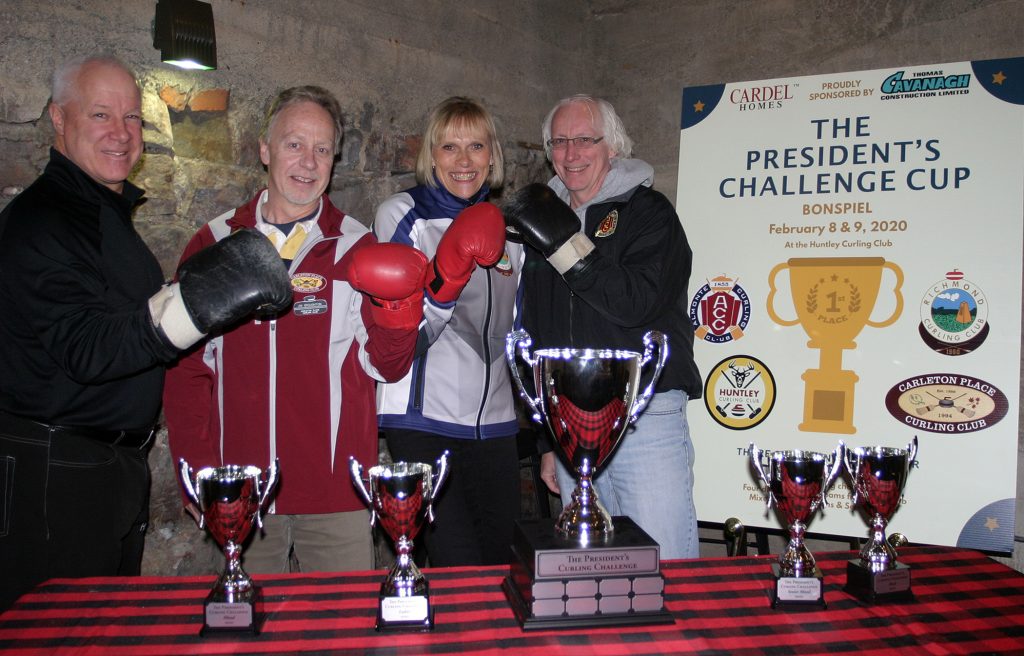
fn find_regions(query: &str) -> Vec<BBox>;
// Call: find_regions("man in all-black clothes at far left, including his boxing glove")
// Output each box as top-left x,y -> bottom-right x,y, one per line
0,56 -> 291,610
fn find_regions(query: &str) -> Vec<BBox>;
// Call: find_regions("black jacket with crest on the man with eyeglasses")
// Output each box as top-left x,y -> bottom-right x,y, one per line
522,186 -> 702,399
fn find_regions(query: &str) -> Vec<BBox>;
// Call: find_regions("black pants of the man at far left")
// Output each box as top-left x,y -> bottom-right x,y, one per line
0,418 -> 150,610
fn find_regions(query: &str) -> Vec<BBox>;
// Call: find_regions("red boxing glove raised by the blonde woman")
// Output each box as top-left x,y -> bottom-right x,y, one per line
427,203 -> 505,303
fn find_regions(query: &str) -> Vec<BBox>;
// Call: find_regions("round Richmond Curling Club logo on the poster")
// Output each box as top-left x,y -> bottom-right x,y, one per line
918,269 -> 988,355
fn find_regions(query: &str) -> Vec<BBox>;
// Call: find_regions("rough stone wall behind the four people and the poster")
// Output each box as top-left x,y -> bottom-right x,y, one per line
0,0 -> 1024,574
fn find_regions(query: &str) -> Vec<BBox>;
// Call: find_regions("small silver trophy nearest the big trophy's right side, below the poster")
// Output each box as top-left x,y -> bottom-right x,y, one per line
750,442 -> 846,608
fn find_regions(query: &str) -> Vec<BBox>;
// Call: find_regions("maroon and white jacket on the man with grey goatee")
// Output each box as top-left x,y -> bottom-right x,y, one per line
164,191 -> 417,514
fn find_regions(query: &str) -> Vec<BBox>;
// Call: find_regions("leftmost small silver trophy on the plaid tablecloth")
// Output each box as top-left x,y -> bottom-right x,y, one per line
178,458 -> 278,635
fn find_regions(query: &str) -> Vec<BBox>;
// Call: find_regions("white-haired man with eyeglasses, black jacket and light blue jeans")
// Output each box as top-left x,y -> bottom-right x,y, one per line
505,95 -> 701,559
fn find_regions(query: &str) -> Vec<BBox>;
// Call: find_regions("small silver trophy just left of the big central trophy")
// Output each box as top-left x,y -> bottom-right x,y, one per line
348,451 -> 449,630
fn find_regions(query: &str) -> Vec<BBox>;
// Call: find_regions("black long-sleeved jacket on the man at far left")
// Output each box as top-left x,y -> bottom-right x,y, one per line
0,149 -> 175,430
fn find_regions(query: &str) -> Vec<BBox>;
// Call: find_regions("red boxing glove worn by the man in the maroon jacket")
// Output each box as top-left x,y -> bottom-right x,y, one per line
343,244 -> 427,330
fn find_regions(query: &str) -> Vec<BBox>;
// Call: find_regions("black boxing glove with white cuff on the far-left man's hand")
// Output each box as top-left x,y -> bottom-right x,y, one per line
150,228 -> 292,350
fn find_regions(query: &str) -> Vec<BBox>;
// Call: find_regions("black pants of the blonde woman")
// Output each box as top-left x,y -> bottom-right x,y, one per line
385,430 -> 520,567
